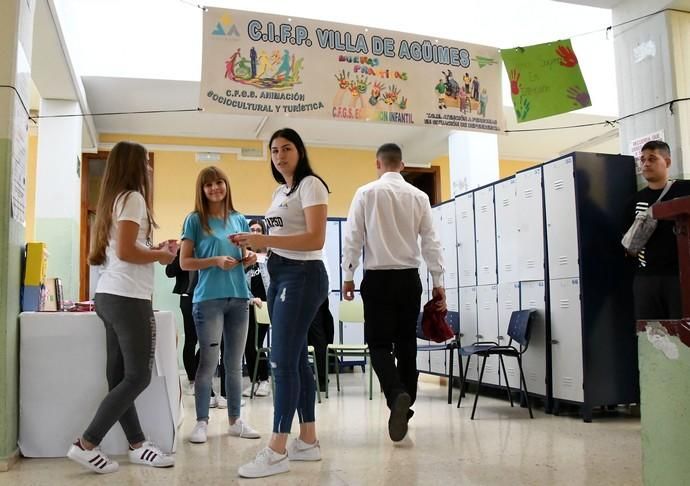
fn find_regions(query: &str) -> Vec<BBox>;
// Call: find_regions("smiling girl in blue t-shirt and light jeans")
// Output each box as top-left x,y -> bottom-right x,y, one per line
180,167 -> 259,444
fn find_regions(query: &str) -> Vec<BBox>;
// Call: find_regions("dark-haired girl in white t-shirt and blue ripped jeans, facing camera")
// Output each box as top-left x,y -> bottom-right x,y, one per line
232,128 -> 328,478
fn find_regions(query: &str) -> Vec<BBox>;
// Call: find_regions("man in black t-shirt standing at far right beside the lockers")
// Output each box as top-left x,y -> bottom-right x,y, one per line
626,140 -> 690,320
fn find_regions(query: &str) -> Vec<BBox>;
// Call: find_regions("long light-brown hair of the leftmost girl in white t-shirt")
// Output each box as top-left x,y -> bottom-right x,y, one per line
89,142 -> 158,265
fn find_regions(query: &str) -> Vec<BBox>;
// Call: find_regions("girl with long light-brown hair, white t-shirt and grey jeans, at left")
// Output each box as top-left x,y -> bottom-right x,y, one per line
67,142 -> 177,474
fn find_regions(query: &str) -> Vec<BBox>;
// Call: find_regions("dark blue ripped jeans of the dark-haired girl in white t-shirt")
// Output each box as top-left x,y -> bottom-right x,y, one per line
266,253 -> 328,433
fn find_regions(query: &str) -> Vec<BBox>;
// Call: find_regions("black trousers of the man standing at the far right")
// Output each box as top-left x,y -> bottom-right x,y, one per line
633,275 -> 683,320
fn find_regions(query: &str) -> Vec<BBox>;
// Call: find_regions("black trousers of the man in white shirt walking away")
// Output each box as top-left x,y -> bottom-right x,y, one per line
360,268 -> 422,408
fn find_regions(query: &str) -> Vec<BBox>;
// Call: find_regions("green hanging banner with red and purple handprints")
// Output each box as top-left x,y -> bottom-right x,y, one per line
501,40 -> 592,123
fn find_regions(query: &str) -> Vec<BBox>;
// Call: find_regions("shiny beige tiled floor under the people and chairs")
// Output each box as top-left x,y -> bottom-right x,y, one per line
0,372 -> 642,486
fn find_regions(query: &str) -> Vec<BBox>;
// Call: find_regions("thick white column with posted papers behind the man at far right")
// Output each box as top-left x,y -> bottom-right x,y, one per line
613,0 -> 690,178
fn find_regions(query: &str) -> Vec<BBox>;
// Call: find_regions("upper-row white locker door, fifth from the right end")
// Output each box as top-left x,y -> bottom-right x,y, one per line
455,193 -> 477,287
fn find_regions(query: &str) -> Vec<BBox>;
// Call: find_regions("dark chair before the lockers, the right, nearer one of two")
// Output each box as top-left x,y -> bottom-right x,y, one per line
458,309 -> 536,420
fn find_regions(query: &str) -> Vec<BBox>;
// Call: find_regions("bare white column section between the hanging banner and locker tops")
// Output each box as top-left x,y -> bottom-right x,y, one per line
448,131 -> 499,197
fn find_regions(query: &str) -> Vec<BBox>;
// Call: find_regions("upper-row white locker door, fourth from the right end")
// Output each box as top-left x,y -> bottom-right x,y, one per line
474,186 -> 496,284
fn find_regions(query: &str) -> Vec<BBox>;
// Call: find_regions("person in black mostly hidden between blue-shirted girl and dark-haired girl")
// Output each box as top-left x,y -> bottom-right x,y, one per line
242,219 -> 271,397
